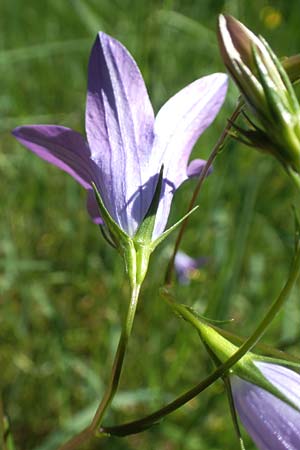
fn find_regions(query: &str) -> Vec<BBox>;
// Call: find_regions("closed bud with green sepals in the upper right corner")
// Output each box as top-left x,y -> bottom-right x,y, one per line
218,16 -> 300,174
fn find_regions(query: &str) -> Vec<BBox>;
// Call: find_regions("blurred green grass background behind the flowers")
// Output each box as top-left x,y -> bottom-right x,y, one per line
0,0 -> 300,450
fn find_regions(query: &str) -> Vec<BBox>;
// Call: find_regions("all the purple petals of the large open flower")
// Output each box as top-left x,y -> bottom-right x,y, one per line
13,32 -> 227,239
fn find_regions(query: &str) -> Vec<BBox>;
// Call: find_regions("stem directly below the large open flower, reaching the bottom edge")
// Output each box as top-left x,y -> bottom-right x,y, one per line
60,285 -> 141,450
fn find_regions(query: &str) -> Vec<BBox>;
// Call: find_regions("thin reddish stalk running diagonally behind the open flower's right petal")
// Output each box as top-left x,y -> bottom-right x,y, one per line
165,102 -> 242,285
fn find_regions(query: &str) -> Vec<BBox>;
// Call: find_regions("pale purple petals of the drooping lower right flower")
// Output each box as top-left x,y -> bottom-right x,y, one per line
230,361 -> 300,450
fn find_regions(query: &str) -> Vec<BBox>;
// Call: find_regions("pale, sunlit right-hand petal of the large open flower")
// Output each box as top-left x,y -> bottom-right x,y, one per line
151,73 -> 227,237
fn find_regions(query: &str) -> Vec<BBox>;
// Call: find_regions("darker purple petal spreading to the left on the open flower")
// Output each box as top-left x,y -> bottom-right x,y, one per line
12,125 -> 97,189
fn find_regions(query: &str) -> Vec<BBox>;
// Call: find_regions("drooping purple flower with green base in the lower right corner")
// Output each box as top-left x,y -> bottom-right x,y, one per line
184,314 -> 300,450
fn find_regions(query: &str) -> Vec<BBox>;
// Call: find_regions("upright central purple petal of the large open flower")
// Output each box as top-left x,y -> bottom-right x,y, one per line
86,33 -> 156,235
